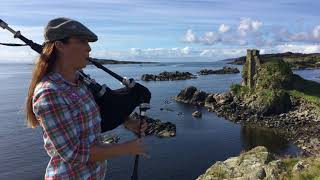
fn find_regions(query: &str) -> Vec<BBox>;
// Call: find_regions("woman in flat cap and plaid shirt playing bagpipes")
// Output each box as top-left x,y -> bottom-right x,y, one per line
26,18 -> 146,179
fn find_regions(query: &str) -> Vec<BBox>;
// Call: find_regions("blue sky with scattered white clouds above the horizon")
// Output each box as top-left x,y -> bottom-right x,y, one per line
0,0 -> 320,63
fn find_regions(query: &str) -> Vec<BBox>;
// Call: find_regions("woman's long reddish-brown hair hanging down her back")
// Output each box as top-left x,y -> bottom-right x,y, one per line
25,38 -> 69,128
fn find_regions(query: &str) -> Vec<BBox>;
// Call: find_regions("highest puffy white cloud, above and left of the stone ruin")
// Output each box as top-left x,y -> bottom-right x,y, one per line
238,18 -> 263,36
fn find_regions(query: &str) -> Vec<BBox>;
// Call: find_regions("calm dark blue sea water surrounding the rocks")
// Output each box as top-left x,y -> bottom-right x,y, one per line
0,61 -> 320,180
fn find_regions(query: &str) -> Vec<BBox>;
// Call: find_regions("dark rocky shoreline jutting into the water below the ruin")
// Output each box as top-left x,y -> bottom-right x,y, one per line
175,86 -> 320,155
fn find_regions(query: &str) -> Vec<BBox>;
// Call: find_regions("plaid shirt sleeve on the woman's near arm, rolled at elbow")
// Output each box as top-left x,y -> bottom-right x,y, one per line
33,89 -> 90,164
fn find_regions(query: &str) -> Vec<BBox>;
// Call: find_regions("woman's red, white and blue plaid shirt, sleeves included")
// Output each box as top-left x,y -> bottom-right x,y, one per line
33,73 -> 106,180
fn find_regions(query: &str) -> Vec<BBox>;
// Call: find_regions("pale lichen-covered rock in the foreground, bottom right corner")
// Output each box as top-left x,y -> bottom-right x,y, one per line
197,146 -> 320,180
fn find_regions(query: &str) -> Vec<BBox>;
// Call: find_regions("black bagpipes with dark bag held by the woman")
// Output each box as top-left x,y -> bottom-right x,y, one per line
0,19 -> 151,132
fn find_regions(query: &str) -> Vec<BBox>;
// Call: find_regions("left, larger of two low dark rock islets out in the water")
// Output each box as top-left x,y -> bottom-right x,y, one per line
141,71 -> 197,81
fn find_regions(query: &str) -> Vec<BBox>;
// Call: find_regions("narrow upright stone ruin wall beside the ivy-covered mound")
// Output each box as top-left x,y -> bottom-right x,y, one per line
242,49 -> 262,89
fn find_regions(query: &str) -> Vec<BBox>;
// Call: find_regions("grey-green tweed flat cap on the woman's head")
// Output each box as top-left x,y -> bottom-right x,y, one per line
44,17 -> 98,42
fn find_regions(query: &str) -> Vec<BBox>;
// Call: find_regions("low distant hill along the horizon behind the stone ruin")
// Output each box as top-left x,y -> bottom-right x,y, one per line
228,52 -> 320,69
